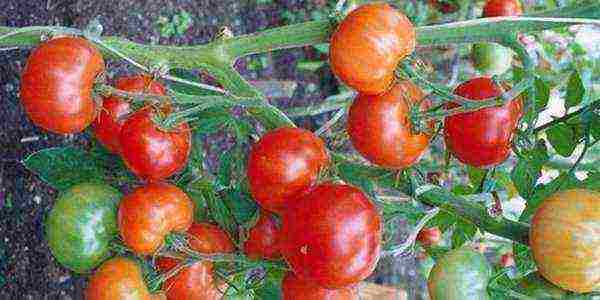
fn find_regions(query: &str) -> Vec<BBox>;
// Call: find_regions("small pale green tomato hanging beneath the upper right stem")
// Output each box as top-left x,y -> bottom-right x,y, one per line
472,43 -> 513,76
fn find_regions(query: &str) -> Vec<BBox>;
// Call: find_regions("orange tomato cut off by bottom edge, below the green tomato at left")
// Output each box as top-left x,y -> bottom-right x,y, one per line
85,257 -> 164,300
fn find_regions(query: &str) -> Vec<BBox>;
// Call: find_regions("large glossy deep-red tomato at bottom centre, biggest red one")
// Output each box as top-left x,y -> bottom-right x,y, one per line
280,183 -> 382,288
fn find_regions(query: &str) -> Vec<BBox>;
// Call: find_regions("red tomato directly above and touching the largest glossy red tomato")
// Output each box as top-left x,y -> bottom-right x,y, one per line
247,127 -> 329,213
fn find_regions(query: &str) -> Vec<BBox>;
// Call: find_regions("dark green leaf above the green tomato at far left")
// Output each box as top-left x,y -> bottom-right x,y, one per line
23,147 -> 106,190
